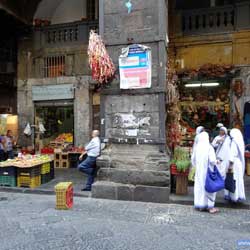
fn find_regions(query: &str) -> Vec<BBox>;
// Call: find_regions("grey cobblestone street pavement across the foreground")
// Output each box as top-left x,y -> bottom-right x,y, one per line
0,192 -> 250,250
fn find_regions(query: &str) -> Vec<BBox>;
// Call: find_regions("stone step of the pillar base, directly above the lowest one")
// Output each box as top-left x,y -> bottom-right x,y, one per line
98,168 -> 170,187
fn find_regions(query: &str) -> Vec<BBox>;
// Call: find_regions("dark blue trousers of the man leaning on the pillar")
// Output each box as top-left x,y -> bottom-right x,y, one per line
78,156 -> 96,189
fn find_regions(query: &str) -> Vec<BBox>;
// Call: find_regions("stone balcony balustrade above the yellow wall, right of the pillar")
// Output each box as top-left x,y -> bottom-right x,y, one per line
174,1 -> 250,36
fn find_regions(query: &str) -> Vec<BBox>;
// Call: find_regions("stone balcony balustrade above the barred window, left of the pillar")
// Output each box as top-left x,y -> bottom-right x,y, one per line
34,21 -> 98,49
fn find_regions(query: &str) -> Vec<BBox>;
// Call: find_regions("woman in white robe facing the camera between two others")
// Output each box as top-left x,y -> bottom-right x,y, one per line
212,127 -> 231,179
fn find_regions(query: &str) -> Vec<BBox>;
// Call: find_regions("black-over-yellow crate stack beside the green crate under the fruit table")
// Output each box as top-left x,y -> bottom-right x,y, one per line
17,166 -> 41,188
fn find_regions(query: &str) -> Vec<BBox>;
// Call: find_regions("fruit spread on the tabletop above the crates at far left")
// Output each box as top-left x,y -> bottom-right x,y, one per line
0,155 -> 53,168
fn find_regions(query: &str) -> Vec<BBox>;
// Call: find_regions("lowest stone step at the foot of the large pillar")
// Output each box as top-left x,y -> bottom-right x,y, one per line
92,181 -> 170,203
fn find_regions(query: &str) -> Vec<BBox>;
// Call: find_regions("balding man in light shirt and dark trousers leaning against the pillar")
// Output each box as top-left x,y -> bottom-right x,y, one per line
78,130 -> 101,191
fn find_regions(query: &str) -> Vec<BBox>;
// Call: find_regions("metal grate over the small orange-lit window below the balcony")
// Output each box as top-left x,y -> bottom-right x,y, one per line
44,55 -> 65,77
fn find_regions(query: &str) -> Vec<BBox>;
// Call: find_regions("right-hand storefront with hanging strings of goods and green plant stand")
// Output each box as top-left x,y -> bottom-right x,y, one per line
166,64 -> 238,195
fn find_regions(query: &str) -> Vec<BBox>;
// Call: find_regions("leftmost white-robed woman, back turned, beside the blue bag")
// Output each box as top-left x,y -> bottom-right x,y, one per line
192,132 -> 218,213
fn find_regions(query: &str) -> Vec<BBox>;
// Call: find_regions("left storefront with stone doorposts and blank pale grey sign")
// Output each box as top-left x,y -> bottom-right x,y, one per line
18,77 -> 92,152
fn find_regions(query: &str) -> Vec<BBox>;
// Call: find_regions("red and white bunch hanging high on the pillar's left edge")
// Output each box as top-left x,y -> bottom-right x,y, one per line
88,30 -> 115,84
